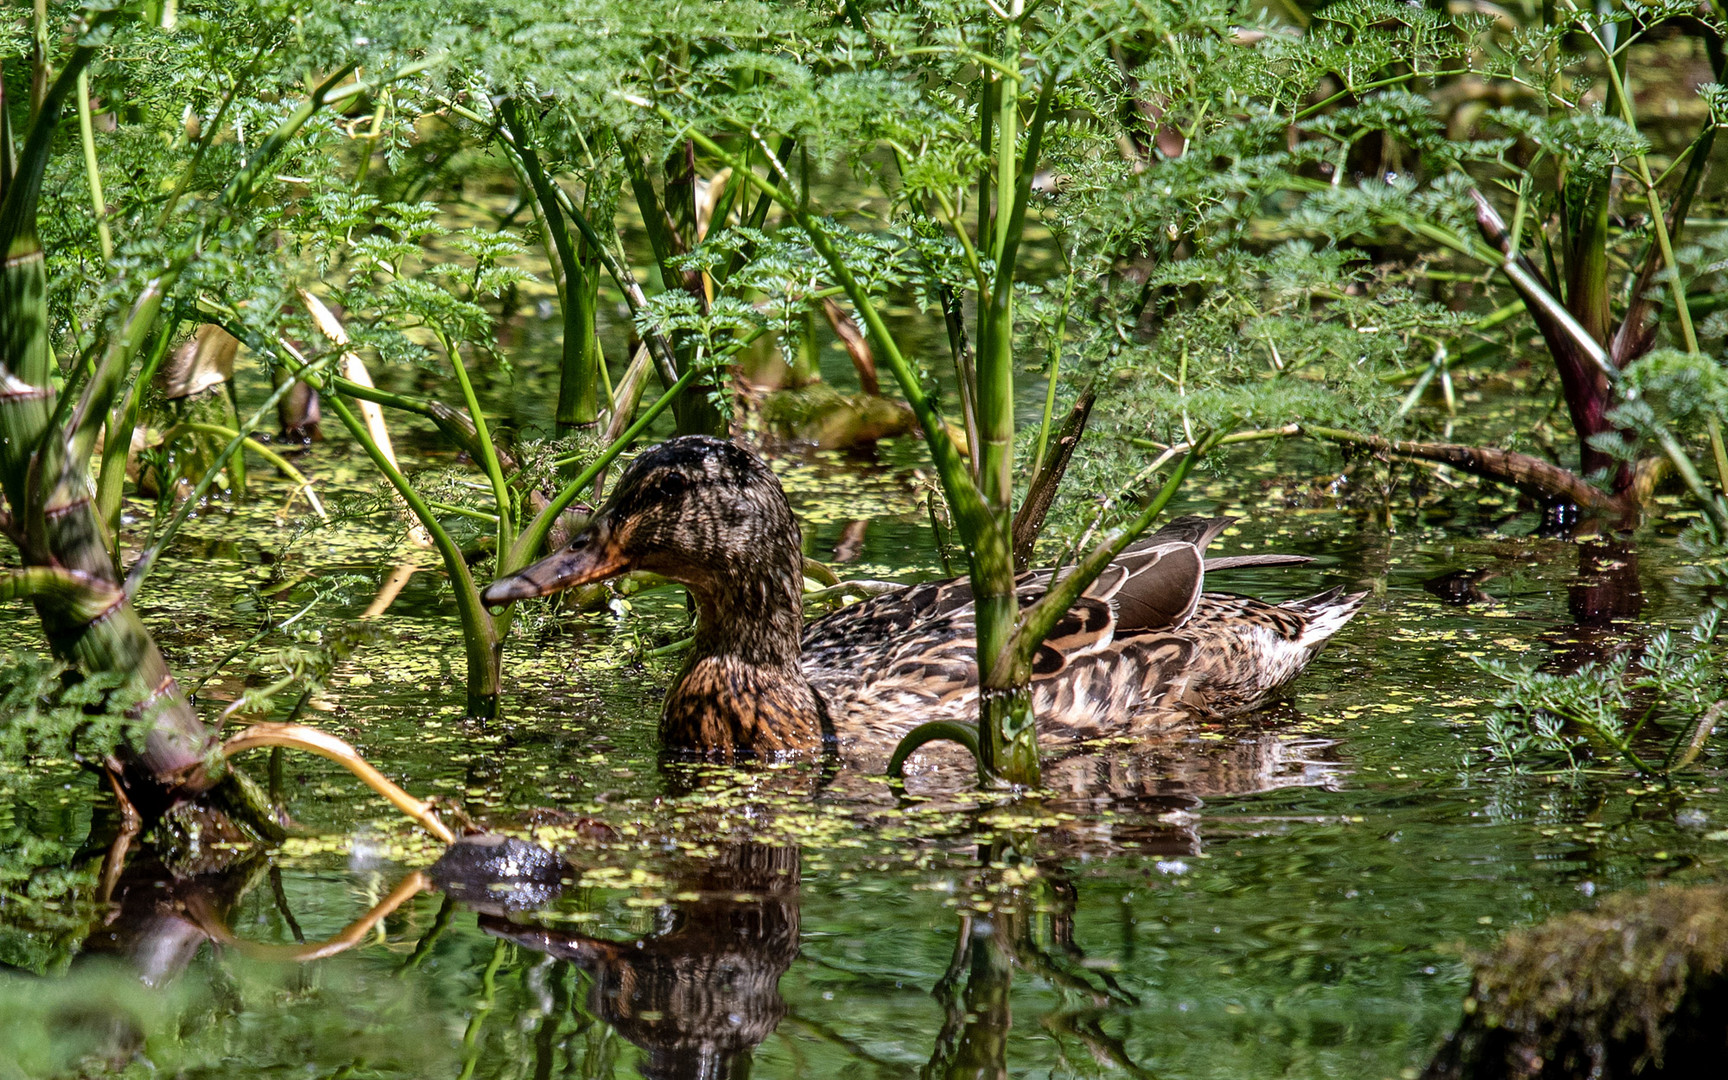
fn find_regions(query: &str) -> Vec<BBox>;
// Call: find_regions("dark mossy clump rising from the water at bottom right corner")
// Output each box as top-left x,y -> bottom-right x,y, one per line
1426,885 -> 1728,1080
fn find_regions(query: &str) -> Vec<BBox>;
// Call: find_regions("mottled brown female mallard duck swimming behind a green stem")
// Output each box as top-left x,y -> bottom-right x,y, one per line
482,435 -> 1367,760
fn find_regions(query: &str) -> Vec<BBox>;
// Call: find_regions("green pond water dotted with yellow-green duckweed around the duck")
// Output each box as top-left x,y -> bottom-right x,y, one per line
0,343 -> 1728,1080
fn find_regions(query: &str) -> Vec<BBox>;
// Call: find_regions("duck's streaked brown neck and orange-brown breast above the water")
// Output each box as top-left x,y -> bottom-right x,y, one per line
660,546 -> 826,760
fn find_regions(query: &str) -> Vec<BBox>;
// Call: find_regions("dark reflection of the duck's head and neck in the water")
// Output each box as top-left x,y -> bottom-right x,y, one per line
480,843 -> 798,1080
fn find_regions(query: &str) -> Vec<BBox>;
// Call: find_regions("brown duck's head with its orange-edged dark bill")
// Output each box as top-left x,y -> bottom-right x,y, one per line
480,435 -> 800,607
